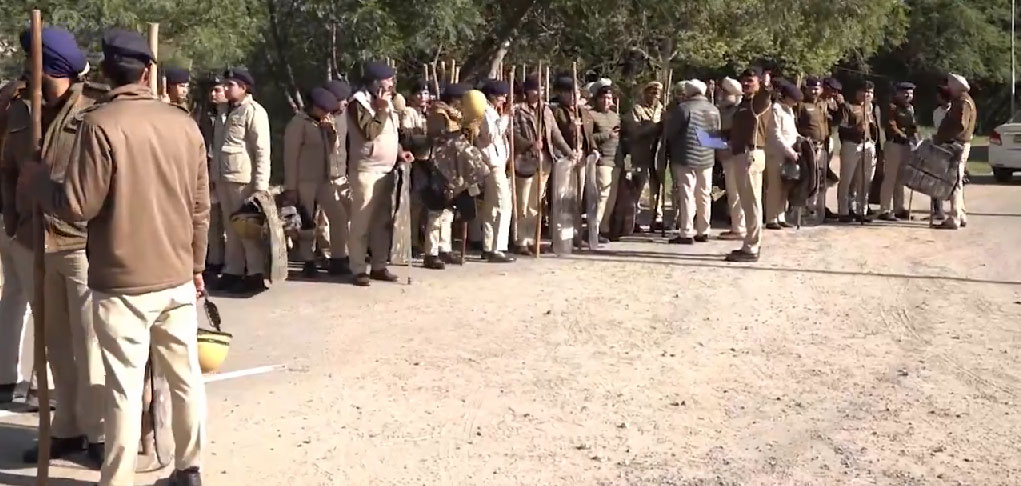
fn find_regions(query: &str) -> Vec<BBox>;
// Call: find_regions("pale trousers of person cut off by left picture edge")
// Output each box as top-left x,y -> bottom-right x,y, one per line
0,228 -> 34,385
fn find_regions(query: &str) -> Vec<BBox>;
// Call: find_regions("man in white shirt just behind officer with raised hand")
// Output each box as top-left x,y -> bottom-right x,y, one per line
766,81 -> 804,231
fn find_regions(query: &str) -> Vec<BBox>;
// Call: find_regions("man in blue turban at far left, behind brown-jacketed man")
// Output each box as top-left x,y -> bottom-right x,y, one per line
0,27 -> 107,467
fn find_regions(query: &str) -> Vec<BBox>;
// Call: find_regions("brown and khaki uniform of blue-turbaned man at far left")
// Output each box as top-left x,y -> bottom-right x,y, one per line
0,83 -> 107,443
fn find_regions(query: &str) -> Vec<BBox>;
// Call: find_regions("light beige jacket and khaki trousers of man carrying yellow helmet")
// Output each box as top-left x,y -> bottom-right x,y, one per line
209,95 -> 270,277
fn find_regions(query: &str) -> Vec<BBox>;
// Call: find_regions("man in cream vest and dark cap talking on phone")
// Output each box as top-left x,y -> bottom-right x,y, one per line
348,62 -> 414,287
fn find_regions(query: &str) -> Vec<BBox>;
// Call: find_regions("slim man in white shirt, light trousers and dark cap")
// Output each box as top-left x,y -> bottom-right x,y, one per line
476,80 -> 515,263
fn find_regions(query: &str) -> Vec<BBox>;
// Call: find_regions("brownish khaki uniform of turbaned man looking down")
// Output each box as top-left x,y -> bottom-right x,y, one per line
284,113 -> 350,261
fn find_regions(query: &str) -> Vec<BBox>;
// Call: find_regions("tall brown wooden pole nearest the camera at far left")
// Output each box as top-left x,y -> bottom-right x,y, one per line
30,10 -> 50,486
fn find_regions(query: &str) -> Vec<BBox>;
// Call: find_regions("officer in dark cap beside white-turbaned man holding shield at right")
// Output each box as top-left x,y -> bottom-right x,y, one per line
879,82 -> 918,222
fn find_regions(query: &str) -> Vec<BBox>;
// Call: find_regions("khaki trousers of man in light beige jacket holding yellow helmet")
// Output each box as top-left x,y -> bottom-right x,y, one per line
216,181 -> 266,276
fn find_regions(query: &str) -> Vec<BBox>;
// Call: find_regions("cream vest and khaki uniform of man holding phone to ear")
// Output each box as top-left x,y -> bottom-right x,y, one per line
348,91 -> 400,275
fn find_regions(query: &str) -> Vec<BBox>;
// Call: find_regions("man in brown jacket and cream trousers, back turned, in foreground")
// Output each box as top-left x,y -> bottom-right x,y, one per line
25,30 -> 209,486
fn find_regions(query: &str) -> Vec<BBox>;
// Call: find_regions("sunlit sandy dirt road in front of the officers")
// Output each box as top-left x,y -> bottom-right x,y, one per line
0,179 -> 1021,486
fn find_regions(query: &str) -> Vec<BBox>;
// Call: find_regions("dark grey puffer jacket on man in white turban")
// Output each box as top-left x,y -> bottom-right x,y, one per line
663,95 -> 720,168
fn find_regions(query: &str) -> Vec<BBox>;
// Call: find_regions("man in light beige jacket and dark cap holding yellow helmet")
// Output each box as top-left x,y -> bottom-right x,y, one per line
209,68 -> 270,294
